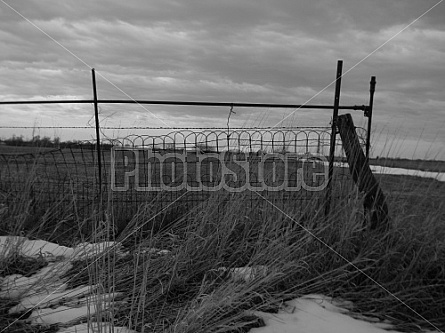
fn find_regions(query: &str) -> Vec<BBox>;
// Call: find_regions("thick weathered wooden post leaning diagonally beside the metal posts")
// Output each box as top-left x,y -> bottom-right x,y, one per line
337,113 -> 389,230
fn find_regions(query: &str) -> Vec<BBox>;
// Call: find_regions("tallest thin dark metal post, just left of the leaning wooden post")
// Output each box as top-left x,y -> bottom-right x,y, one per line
325,60 -> 343,216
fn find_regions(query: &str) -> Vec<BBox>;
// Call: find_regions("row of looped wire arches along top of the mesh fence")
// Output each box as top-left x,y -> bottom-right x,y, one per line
106,127 -> 366,154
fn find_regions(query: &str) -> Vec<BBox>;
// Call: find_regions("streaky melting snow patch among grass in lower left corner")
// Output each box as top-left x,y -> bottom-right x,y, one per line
0,236 -> 136,333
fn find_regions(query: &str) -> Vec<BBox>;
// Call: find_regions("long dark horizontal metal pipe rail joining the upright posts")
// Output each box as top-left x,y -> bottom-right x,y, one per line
0,99 -> 368,111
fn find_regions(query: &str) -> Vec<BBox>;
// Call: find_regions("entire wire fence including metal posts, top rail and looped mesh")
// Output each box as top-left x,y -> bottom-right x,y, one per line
0,61 -> 375,228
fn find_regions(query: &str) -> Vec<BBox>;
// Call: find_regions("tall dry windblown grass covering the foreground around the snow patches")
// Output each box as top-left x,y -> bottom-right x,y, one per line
0,144 -> 445,332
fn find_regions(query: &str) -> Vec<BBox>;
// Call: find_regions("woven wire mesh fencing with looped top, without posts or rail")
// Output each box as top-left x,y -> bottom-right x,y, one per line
0,127 -> 366,223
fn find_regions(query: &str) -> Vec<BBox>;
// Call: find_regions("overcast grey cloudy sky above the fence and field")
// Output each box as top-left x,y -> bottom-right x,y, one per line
0,0 -> 445,160
